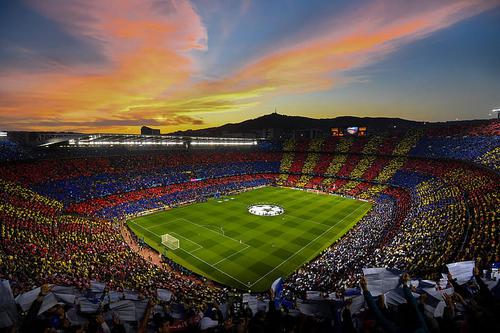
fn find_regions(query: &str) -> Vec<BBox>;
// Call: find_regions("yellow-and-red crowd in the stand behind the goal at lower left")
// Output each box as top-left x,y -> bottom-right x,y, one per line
0,176 -> 224,312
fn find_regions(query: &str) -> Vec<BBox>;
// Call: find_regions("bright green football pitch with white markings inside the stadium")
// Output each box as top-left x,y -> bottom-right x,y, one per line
127,187 -> 371,291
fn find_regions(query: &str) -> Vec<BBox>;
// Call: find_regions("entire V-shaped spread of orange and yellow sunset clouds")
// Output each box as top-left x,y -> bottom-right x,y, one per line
0,0 -> 498,132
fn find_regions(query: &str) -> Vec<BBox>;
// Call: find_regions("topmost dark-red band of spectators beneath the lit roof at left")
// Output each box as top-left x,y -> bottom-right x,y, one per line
0,151 -> 281,186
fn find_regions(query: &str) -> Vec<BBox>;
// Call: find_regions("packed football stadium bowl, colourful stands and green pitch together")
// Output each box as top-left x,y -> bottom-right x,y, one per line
0,121 -> 500,329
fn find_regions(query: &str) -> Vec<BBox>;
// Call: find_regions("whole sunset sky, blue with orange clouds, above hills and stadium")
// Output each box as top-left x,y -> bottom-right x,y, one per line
0,0 -> 500,133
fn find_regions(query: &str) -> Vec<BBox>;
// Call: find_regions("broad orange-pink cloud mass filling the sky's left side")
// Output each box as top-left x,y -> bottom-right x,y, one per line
0,0 -> 207,129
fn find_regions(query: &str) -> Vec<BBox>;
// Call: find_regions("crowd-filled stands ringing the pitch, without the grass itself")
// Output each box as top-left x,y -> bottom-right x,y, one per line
0,121 -> 500,332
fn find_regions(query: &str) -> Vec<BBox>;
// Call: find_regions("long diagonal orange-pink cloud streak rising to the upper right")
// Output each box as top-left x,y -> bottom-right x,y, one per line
198,0 -> 495,94
